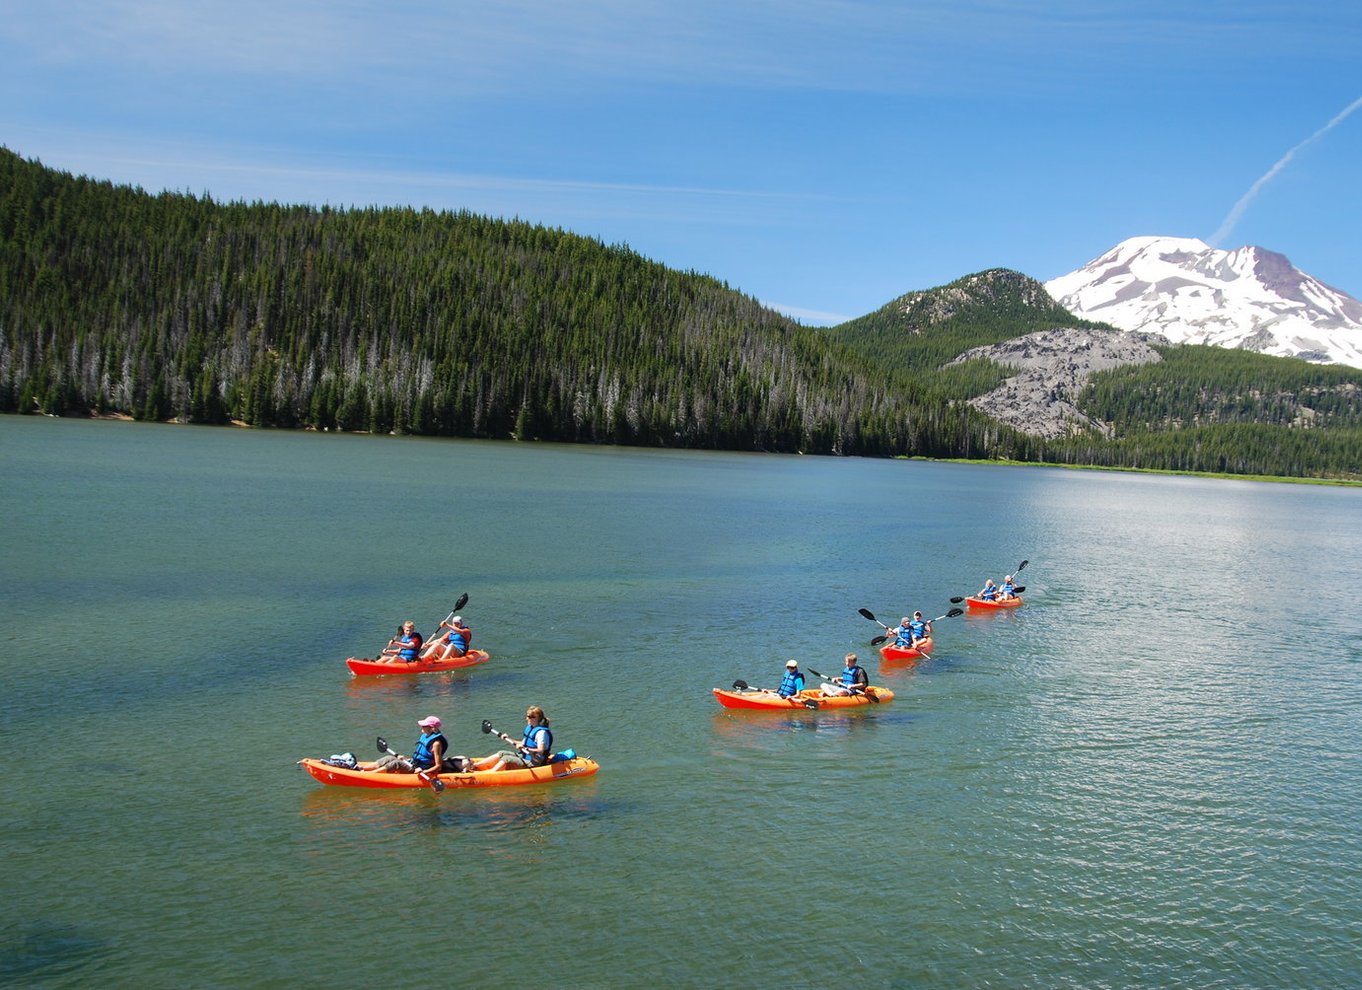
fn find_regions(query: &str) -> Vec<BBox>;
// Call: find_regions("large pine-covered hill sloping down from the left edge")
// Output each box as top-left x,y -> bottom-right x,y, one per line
0,148 -> 1027,456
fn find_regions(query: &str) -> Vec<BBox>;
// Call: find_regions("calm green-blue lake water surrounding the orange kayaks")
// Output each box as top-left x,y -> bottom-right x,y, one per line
0,417 -> 1362,989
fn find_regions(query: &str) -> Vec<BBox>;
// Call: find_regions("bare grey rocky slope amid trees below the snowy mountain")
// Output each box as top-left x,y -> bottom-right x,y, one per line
951,330 -> 1167,438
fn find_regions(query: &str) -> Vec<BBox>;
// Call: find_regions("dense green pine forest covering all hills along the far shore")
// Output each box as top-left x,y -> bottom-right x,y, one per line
0,148 -> 1362,479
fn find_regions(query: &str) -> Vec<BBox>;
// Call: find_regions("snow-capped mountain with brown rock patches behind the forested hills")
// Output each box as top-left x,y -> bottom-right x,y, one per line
1045,237 -> 1362,368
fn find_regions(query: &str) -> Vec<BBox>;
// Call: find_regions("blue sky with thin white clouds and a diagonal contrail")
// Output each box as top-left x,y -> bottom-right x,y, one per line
0,0 -> 1362,324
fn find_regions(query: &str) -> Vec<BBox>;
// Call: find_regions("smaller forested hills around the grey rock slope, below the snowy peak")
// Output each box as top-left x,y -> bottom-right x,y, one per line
829,268 -> 1362,481
